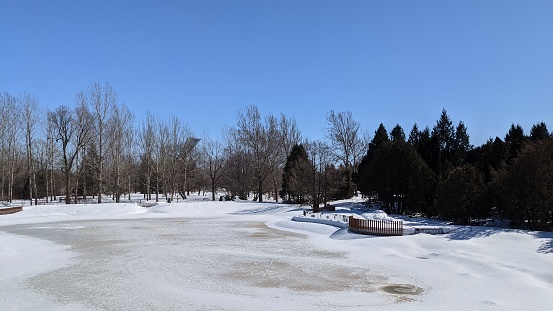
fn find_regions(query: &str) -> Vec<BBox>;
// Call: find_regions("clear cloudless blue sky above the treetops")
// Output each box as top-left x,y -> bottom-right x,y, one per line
0,0 -> 553,145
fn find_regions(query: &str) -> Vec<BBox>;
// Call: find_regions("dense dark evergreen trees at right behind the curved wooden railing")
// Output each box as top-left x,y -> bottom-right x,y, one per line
357,110 -> 553,230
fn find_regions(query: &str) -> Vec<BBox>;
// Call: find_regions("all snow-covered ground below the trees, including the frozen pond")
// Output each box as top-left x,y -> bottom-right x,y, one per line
0,197 -> 553,310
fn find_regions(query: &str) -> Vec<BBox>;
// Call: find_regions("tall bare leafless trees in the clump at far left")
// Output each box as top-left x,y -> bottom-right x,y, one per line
0,82 -> 200,204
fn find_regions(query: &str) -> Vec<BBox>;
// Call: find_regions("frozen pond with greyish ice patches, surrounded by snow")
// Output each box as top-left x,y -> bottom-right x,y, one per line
1,219 -> 410,310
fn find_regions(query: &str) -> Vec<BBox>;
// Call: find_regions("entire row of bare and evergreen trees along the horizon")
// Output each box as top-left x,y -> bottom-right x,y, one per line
0,82 -> 553,230
